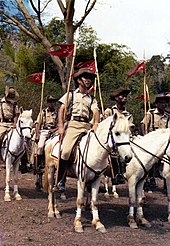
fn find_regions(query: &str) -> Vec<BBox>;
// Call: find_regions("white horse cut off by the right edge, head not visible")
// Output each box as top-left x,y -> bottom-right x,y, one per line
126,129 -> 170,228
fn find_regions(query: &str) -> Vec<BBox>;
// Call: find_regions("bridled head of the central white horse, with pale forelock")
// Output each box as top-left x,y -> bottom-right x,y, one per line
108,114 -> 132,163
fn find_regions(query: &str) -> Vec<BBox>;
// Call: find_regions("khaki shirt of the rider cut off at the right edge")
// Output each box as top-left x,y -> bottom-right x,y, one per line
141,108 -> 170,132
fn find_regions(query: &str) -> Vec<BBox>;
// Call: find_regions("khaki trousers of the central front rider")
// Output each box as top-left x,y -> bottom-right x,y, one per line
61,120 -> 91,160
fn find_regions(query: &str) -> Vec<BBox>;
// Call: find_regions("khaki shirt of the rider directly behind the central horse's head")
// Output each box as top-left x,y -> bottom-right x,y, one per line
104,105 -> 134,126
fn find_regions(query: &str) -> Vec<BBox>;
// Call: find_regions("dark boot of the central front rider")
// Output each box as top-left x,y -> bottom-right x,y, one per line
57,159 -> 68,193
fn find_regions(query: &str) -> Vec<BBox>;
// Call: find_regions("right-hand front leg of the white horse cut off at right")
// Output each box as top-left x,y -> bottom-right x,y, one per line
136,180 -> 151,228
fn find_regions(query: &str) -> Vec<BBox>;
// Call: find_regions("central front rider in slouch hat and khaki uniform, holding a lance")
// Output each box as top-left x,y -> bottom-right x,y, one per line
58,68 -> 100,192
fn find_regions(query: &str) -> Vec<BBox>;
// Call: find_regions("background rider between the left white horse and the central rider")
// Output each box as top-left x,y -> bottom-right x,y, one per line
35,96 -> 58,170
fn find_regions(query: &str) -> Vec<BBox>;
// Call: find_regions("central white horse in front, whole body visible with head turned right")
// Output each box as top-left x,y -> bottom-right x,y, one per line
44,115 -> 132,232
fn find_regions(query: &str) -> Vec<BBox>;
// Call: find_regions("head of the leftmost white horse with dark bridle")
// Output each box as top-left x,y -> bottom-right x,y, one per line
16,108 -> 33,139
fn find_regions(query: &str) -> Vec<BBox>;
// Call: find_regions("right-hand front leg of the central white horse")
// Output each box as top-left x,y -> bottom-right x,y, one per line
91,178 -> 106,233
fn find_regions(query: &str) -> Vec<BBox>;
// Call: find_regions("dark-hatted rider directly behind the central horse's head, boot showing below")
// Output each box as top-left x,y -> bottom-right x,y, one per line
104,87 -> 134,185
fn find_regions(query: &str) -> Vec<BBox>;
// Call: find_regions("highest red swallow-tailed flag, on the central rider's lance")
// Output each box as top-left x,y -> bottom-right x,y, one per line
48,44 -> 74,58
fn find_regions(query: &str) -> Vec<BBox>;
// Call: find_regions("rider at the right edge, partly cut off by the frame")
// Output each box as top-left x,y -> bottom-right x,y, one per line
141,94 -> 170,191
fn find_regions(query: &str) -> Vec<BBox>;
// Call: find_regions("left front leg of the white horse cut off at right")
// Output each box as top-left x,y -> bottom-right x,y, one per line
127,177 -> 138,229
